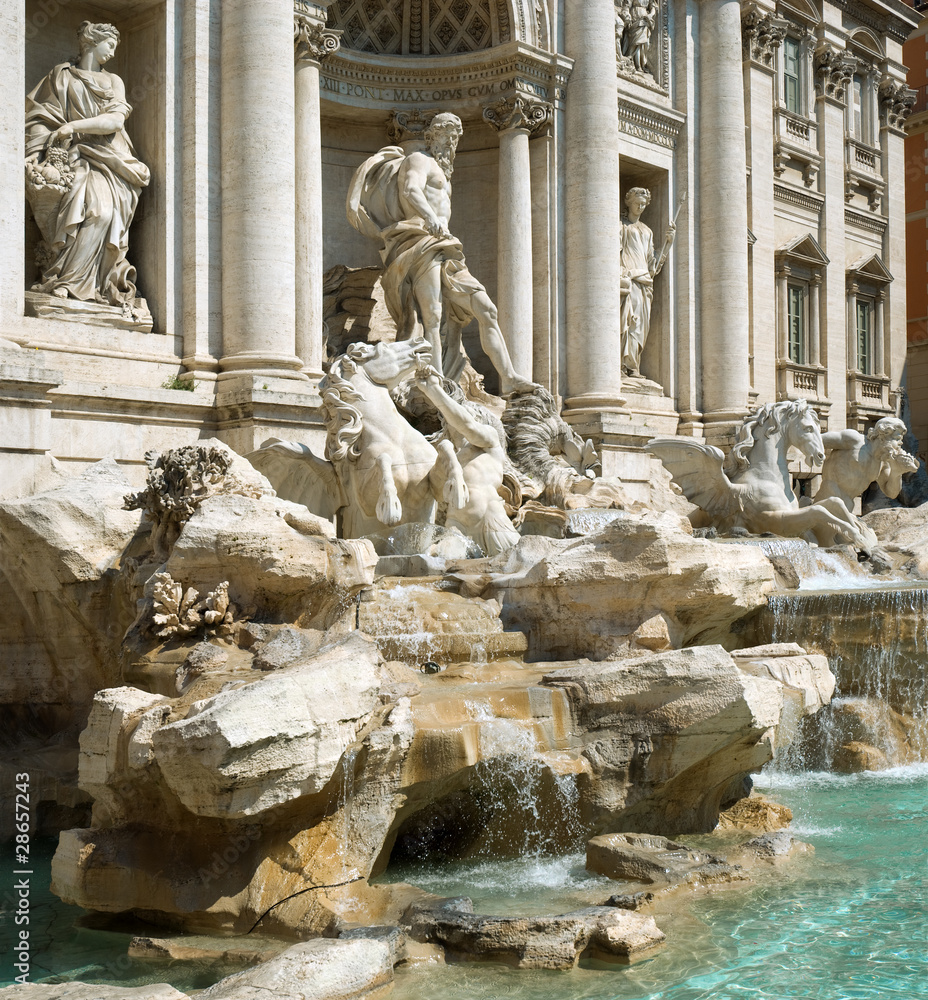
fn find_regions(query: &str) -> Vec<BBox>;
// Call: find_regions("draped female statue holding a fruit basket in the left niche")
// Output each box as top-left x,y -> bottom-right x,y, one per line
26,21 -> 150,323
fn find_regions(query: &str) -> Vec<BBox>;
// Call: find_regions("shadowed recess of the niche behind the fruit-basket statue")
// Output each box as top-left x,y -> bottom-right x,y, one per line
23,0 -> 172,333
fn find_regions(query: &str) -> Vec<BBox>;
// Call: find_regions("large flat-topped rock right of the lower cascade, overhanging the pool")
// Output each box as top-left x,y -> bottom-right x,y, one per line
545,646 -> 833,836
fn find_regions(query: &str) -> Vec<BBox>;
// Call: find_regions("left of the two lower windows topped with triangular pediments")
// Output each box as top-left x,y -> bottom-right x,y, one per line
774,233 -> 829,400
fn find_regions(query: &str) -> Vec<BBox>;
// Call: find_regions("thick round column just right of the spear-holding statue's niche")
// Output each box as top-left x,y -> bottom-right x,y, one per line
697,0 -> 750,439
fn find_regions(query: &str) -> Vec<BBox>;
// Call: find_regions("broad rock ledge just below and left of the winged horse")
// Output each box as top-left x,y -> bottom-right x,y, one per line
468,514 -> 774,659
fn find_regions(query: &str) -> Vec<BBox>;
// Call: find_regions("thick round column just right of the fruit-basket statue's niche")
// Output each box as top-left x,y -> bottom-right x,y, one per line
219,0 -> 306,380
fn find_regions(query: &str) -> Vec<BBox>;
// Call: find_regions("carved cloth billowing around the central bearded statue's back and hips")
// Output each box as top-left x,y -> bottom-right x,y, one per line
347,146 -> 485,340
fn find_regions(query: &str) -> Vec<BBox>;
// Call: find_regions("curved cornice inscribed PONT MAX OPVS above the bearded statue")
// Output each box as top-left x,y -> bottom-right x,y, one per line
320,42 -> 573,119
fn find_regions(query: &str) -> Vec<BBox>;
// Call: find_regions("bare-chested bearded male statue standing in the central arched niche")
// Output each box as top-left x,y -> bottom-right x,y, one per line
347,113 -> 536,396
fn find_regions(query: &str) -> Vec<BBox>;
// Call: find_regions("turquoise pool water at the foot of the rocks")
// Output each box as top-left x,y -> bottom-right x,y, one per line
0,764 -> 928,1000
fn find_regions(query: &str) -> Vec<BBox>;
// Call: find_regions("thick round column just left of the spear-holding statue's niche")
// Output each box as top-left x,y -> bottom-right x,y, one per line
564,0 -> 628,412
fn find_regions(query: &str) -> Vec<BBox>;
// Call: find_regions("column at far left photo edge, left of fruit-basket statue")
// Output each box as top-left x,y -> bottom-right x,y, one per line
0,2 -> 24,347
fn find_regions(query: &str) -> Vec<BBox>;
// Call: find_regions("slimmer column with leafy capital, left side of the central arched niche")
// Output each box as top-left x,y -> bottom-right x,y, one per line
293,4 -> 341,378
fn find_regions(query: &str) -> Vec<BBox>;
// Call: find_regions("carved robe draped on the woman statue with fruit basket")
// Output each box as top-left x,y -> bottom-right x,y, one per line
26,63 -> 151,305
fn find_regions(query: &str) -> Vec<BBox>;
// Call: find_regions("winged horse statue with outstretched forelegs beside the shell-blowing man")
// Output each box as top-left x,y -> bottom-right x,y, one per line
648,399 -> 877,555
